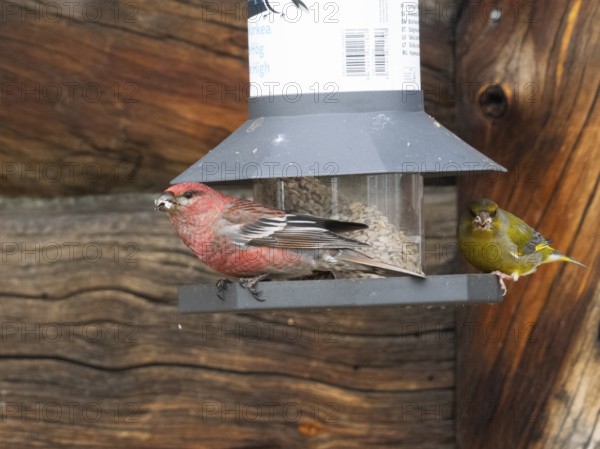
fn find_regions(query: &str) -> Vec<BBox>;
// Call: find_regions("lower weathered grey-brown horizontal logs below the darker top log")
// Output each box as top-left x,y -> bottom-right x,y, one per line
0,187 -> 456,449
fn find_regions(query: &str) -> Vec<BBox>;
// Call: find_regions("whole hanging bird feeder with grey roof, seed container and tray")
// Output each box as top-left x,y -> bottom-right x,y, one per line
172,0 -> 505,312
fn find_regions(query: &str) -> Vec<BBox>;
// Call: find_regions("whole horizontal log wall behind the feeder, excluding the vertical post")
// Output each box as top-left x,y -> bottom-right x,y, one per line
0,0 -> 464,449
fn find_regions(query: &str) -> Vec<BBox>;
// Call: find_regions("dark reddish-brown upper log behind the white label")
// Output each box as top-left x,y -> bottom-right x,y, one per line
0,0 -> 455,196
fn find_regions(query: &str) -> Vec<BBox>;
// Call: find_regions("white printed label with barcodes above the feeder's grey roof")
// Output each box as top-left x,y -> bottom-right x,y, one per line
248,0 -> 421,98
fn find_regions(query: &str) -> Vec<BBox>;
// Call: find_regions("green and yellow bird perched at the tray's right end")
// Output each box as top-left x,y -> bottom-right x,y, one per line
457,198 -> 585,294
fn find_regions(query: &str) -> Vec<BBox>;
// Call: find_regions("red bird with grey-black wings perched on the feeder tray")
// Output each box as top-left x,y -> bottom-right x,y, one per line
155,182 -> 424,299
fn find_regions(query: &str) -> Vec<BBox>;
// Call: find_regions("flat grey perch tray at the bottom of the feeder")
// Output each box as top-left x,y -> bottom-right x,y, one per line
179,274 -> 502,313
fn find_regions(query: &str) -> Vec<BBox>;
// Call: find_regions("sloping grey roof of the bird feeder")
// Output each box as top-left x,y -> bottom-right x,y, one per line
172,91 -> 506,184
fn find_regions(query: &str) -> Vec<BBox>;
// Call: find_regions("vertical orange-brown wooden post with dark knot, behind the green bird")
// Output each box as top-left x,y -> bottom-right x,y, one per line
456,0 -> 600,449
